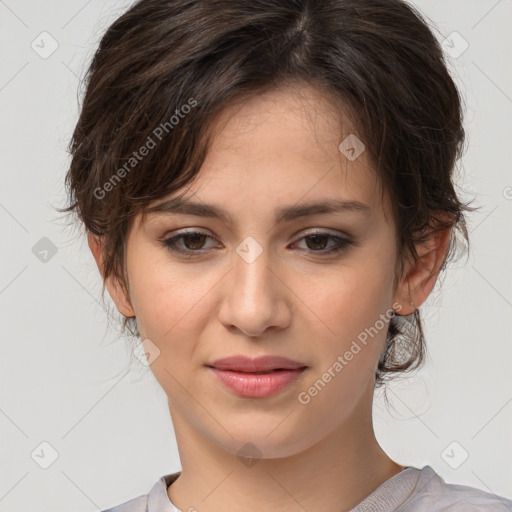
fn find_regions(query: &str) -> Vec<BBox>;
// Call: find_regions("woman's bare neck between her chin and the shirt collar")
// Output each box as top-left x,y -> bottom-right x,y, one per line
167,386 -> 404,512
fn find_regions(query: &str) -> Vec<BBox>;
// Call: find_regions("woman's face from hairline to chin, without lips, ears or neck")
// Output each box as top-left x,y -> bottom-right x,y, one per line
104,87 -> 408,457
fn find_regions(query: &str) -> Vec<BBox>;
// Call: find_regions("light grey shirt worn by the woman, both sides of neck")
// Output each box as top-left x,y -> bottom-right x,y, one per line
103,466 -> 512,512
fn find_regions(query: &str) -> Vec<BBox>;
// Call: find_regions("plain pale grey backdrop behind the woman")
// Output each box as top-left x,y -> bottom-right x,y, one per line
0,0 -> 512,512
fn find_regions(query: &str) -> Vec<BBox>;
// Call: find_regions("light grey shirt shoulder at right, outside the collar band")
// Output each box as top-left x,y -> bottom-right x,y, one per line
397,466 -> 512,512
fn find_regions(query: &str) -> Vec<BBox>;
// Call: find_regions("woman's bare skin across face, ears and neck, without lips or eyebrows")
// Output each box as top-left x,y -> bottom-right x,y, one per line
89,86 -> 449,512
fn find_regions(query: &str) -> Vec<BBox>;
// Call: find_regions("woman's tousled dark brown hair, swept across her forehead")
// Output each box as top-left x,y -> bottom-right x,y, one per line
61,0 -> 473,387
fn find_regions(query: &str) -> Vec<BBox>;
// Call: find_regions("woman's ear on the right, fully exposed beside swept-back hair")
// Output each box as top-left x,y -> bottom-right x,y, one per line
395,217 -> 451,315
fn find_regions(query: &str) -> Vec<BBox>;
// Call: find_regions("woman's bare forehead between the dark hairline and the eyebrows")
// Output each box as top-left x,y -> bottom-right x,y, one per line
136,86 -> 392,230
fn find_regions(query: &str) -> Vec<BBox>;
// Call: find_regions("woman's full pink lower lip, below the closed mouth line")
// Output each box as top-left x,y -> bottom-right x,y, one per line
210,367 -> 306,398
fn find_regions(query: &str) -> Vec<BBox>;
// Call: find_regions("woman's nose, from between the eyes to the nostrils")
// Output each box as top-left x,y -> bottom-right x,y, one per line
219,239 -> 293,337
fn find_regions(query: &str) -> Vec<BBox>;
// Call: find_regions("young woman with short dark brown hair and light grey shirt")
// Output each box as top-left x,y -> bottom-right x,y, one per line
60,0 -> 512,512
